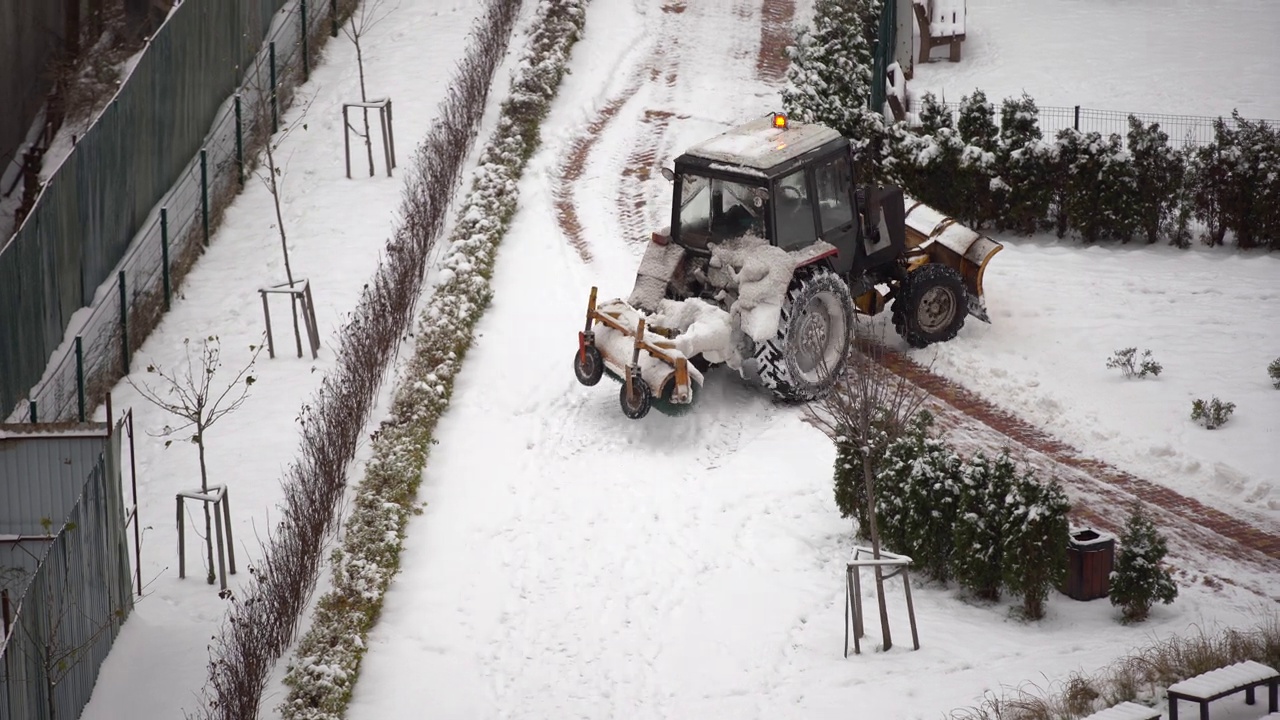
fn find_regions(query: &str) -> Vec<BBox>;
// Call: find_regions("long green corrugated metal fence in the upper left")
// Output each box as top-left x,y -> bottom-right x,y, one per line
0,0 -> 298,420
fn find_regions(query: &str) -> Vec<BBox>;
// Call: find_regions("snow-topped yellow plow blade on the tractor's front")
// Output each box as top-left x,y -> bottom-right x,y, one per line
906,196 -> 1004,323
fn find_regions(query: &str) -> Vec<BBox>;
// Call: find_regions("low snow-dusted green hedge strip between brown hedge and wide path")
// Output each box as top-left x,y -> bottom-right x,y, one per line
280,0 -> 586,720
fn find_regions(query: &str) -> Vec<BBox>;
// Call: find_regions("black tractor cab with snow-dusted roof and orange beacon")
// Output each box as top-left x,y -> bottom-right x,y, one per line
664,114 -> 901,274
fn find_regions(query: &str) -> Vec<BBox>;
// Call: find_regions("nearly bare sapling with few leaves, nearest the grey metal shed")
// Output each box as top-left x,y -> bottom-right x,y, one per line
128,336 -> 262,584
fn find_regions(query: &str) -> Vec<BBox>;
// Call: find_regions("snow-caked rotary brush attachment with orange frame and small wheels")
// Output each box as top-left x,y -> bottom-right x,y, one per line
573,287 -> 703,420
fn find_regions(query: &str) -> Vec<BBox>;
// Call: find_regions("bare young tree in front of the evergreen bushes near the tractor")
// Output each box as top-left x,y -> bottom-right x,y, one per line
812,323 -> 927,650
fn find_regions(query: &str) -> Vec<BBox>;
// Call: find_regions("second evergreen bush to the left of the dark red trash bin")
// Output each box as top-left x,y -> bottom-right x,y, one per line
951,452 -> 1018,601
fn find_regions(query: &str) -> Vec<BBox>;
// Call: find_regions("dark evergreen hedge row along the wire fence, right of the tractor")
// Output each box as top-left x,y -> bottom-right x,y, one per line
859,91 -> 1280,250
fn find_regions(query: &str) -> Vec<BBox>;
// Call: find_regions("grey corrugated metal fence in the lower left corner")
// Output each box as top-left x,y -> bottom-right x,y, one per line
0,432 -> 133,720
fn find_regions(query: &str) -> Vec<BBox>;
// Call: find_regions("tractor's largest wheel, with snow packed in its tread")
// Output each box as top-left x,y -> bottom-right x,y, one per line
754,268 -> 855,401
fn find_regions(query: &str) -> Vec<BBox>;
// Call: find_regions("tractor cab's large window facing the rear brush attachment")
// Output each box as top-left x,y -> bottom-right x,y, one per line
677,173 -> 767,250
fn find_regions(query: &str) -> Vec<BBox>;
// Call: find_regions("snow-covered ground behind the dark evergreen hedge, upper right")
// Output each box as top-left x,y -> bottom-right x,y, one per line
909,0 -> 1280,120
